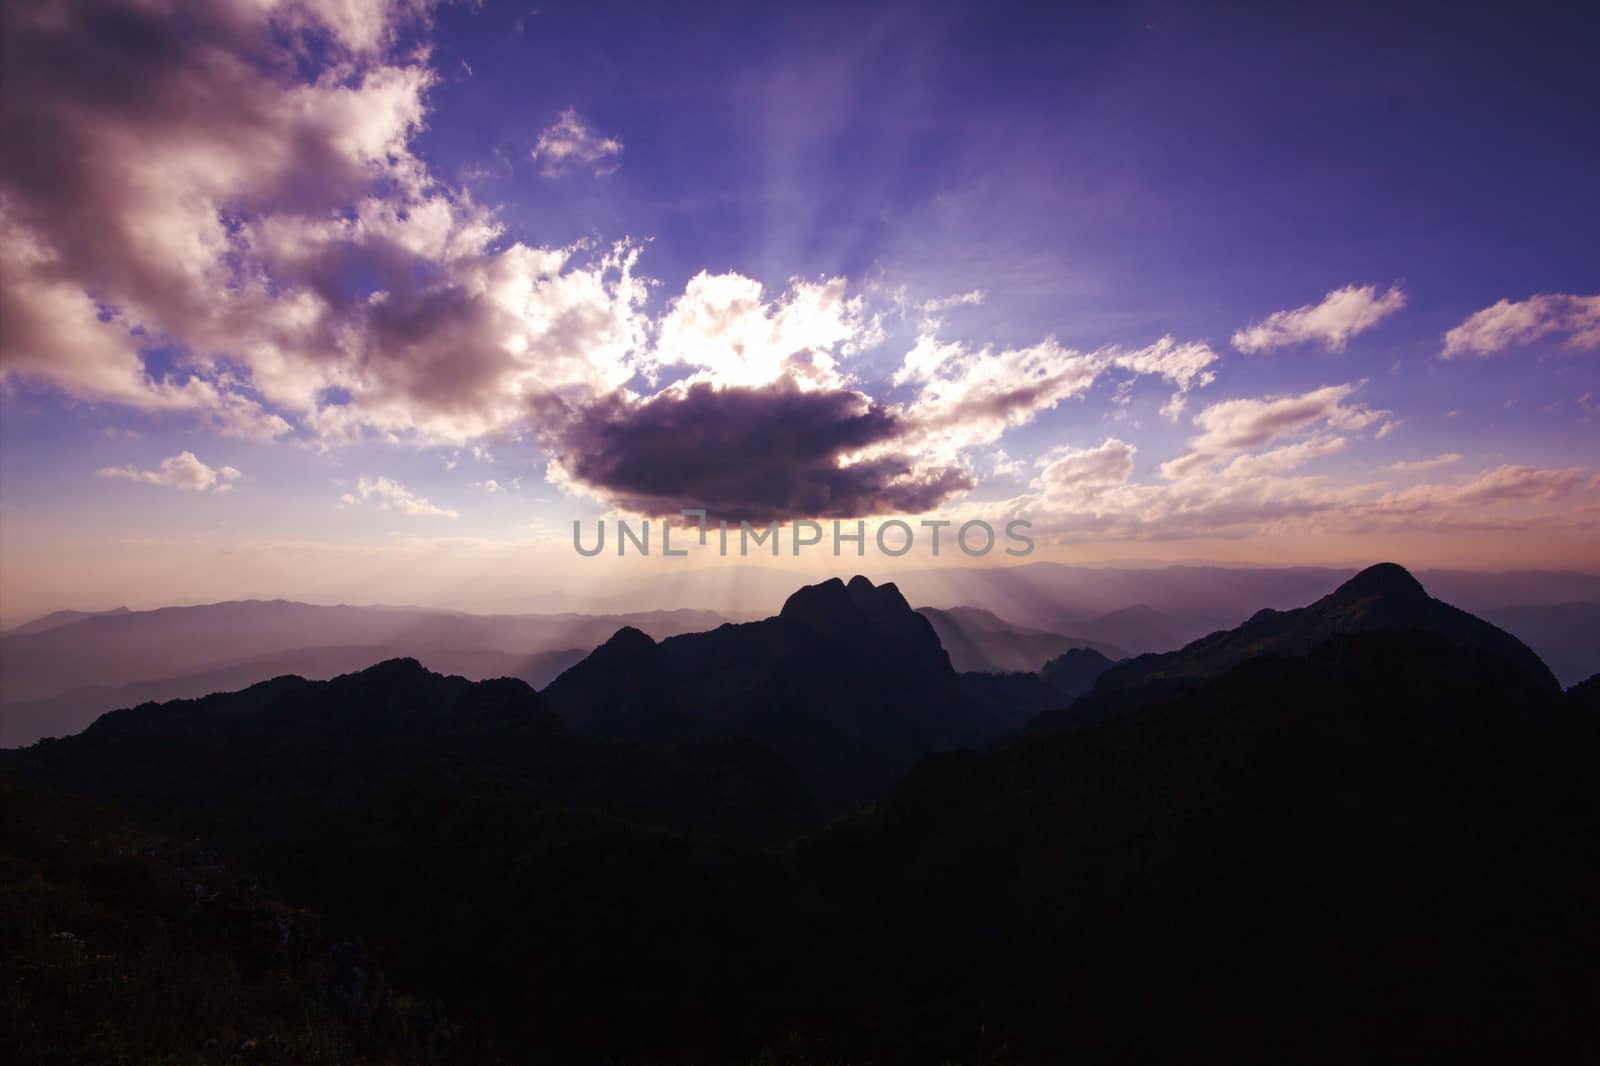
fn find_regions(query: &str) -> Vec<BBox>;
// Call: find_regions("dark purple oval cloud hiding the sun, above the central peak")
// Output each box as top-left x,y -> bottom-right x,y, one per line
554,384 -> 973,522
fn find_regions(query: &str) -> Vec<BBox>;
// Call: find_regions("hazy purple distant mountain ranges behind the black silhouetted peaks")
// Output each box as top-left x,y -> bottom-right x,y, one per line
12,563 -> 1600,747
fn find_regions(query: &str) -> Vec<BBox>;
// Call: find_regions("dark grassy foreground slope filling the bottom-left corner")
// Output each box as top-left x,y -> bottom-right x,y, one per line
0,787 -> 451,1066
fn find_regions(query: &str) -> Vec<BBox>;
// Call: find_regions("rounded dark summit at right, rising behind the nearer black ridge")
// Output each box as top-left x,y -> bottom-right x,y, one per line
1054,563 -> 1560,723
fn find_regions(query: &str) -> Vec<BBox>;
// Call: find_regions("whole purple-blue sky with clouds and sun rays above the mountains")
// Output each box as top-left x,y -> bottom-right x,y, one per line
0,0 -> 1600,624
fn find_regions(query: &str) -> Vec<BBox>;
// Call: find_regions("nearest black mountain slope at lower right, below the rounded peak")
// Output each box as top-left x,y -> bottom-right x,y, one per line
795,631 -> 1600,1064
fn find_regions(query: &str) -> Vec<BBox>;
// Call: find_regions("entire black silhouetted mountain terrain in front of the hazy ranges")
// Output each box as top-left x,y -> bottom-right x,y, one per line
0,567 -> 1600,1063
